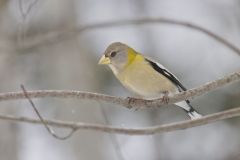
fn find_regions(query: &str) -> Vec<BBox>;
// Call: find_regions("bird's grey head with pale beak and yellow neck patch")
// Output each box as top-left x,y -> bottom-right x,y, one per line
98,42 -> 137,71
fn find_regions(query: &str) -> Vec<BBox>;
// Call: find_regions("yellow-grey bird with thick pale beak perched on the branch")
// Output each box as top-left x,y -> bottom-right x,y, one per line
98,42 -> 202,120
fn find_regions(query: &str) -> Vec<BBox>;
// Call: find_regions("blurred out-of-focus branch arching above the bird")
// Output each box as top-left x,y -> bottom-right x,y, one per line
20,18 -> 240,55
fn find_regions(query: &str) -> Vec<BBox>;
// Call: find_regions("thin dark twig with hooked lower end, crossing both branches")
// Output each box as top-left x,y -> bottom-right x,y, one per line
21,85 -> 76,140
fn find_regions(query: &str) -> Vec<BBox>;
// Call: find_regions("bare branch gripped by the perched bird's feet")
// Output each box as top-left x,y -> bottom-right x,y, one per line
0,72 -> 240,108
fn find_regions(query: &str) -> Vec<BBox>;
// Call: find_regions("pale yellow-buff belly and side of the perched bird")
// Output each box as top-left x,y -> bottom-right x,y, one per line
116,58 -> 176,98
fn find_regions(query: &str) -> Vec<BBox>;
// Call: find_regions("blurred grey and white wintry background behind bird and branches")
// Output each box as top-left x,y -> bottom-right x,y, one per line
0,0 -> 240,160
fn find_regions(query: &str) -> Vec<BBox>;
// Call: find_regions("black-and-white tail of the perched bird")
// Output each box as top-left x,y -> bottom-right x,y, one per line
175,100 -> 202,120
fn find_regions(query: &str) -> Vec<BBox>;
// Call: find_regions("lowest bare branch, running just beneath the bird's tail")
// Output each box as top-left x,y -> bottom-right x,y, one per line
0,107 -> 240,135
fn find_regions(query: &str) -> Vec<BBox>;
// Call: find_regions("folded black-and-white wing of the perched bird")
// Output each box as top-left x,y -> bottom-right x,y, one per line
145,58 -> 187,91
